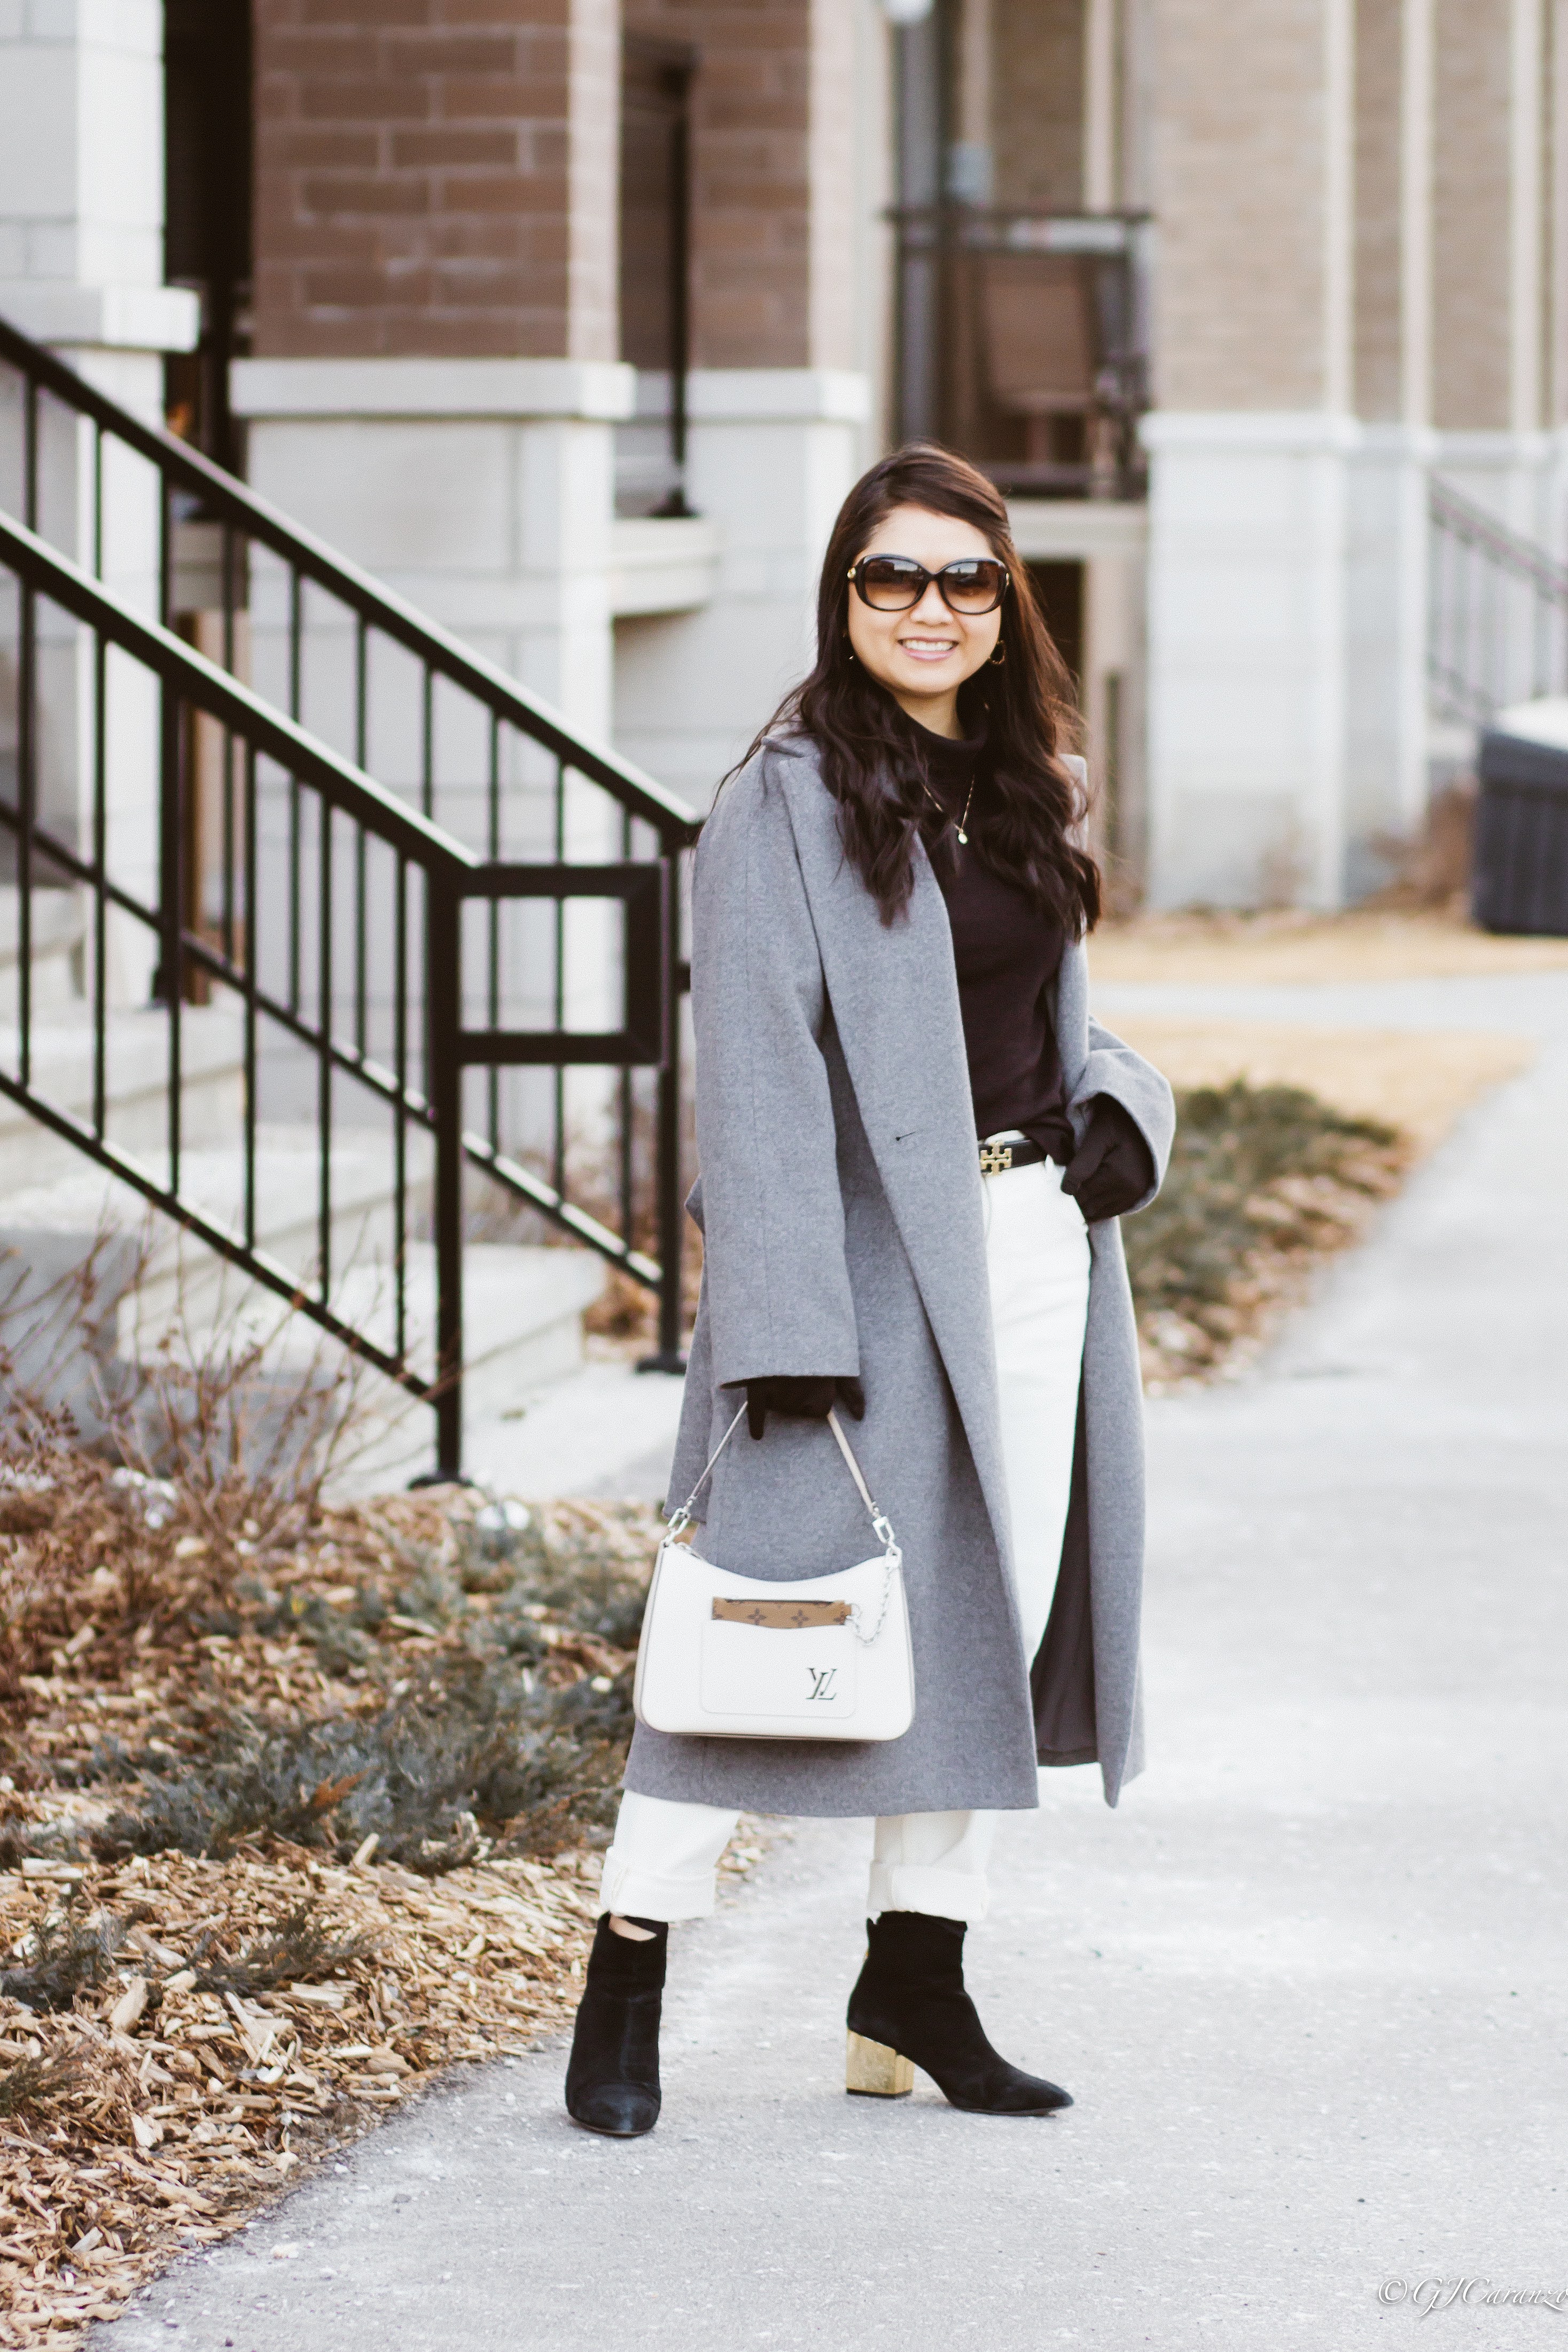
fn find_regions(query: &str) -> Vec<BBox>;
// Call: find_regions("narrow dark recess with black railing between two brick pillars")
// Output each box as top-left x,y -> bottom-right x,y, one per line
618,33 -> 696,515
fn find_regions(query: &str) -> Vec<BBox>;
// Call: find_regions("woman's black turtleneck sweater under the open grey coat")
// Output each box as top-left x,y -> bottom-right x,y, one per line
908,720 -> 1074,1166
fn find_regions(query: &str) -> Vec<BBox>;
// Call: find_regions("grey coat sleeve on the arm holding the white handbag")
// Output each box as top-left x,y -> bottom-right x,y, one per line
691,753 -> 861,1388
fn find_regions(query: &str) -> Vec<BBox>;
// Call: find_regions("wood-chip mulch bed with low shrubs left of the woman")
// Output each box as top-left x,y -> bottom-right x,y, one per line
0,1467 -> 667,2345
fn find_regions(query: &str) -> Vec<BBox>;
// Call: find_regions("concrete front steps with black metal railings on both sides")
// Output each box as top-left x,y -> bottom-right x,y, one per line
0,324 -> 696,1475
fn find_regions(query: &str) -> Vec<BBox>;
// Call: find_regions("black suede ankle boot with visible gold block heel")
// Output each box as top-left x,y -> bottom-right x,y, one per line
849,1912 -> 1072,2114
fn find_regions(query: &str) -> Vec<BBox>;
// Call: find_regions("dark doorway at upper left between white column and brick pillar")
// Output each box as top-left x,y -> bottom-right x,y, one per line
165,0 -> 252,473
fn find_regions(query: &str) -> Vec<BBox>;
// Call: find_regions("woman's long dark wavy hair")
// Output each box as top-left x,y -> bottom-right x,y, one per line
731,442 -> 1100,938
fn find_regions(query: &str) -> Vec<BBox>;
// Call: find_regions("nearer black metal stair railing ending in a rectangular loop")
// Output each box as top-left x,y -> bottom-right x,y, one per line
0,515 -> 675,1473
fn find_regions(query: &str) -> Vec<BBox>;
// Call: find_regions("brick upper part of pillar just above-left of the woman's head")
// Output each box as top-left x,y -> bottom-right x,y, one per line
625,0 -> 853,367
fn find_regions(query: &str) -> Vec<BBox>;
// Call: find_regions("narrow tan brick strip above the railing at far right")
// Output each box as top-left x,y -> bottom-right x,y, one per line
1432,0 -> 1509,433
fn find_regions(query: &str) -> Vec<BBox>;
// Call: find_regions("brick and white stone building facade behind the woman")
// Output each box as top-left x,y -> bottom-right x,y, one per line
0,0 -> 1568,906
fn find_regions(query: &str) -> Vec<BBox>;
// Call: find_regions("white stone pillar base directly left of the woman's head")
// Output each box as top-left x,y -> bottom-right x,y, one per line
616,367 -> 870,809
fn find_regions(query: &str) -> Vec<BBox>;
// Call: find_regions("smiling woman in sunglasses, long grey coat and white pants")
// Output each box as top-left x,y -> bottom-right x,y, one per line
566,445 -> 1173,2136
